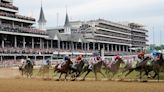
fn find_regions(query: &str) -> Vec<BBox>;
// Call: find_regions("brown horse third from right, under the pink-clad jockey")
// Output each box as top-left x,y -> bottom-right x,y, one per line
105,58 -> 124,78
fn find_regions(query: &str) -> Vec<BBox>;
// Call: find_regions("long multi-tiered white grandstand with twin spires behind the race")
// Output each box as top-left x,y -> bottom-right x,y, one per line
0,0 -> 147,64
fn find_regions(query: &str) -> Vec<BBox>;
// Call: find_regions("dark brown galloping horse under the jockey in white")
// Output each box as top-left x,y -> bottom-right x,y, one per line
81,57 -> 105,81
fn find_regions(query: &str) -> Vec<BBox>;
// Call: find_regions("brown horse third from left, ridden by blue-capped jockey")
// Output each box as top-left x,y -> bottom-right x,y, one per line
54,59 -> 72,80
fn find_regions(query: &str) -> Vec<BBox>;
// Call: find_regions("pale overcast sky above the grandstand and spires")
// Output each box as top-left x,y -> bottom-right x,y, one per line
14,0 -> 164,44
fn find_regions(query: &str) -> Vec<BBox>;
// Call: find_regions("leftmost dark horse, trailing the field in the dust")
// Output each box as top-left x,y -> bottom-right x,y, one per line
19,60 -> 33,78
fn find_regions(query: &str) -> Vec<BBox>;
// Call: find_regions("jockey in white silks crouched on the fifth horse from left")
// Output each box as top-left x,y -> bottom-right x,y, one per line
88,54 -> 102,70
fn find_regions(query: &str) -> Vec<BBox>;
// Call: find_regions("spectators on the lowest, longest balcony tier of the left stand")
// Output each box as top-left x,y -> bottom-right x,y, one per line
0,24 -> 47,35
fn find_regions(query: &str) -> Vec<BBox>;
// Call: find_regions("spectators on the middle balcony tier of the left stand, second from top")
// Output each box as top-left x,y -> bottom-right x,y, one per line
0,12 -> 35,21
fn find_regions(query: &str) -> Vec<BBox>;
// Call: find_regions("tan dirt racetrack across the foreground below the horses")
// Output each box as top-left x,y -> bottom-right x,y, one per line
0,69 -> 164,92
